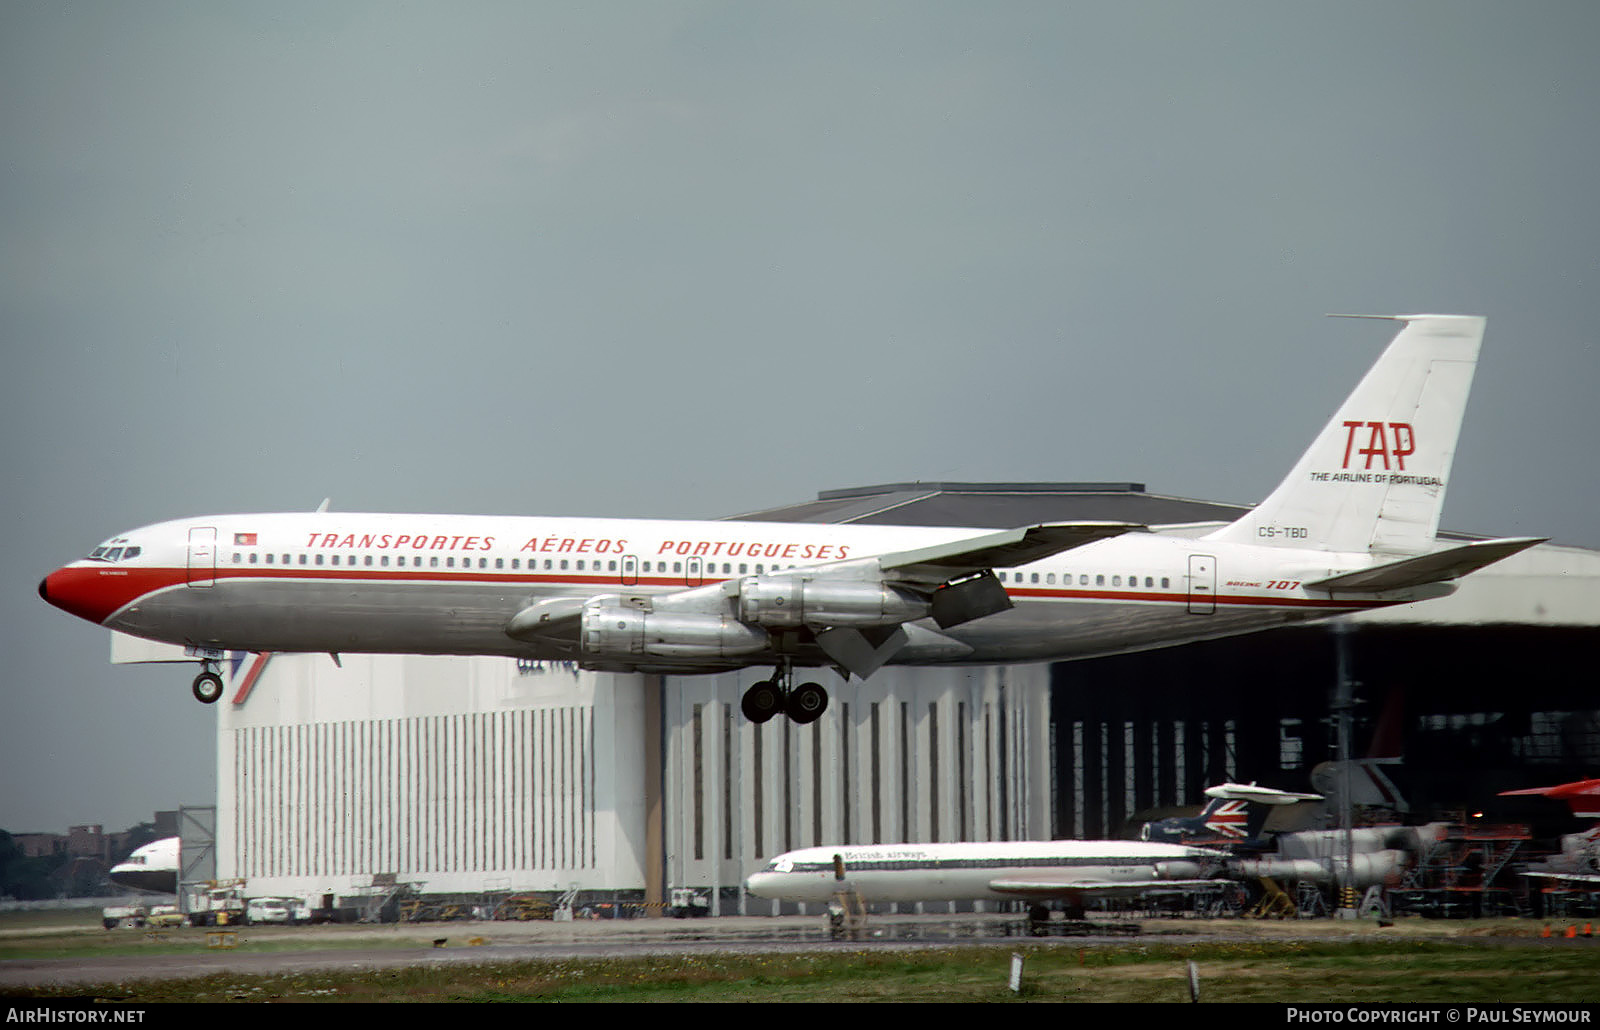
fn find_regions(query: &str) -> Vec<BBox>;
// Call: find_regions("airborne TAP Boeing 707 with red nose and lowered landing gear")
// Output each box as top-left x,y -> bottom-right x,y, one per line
38,315 -> 1542,723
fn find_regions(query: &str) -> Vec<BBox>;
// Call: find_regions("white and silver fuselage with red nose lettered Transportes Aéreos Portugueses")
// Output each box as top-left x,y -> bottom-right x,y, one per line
40,513 -> 1414,670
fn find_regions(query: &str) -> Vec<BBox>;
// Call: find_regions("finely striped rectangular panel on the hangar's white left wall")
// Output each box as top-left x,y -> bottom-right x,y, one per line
227,705 -> 598,878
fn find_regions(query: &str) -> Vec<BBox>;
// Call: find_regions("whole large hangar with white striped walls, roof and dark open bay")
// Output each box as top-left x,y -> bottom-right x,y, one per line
121,483 -> 1600,915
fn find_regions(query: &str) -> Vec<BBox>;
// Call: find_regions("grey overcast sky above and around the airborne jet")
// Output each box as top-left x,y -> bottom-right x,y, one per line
0,0 -> 1600,832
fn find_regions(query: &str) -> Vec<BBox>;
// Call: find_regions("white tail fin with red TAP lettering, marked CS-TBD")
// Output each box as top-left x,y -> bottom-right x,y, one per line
1210,315 -> 1485,555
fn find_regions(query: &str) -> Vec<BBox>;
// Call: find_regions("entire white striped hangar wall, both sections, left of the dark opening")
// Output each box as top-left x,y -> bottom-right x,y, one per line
187,654 -> 1050,913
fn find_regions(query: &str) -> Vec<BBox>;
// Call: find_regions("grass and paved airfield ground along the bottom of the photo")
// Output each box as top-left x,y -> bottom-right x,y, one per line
0,912 -> 1600,1004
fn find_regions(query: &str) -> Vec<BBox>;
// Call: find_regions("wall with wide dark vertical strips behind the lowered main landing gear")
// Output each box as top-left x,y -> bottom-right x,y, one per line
662,665 -> 1053,912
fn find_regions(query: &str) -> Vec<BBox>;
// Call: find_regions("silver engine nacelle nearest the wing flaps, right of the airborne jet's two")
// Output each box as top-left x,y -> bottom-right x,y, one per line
739,576 -> 931,629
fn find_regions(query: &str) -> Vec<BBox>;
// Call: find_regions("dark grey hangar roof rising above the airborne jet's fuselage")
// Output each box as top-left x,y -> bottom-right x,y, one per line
728,483 -> 1250,529
